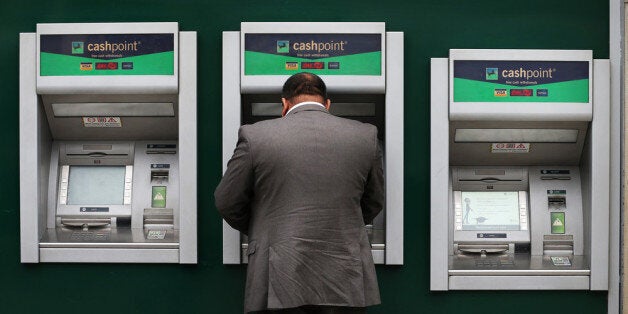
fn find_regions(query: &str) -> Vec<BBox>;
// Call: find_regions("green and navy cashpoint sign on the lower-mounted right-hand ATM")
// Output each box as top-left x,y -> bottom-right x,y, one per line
453,60 -> 590,103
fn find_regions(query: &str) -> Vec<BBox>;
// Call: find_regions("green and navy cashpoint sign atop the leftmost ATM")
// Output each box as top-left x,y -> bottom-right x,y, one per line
39,34 -> 175,76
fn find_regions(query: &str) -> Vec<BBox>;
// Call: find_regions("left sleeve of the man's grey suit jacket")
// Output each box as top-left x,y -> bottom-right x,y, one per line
214,127 -> 254,234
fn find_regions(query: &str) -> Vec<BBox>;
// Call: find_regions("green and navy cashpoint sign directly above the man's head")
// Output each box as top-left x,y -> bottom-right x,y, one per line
244,34 -> 382,75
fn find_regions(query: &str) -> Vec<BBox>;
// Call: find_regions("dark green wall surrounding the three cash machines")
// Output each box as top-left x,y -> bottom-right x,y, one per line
0,0 -> 609,313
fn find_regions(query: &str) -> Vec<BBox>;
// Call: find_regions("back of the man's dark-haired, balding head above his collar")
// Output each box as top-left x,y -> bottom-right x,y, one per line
281,72 -> 331,115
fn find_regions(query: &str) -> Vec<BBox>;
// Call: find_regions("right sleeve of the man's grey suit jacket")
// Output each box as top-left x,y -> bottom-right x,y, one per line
360,128 -> 385,224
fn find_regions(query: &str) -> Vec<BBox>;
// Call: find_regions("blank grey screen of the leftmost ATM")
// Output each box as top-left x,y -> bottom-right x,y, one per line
67,166 -> 126,205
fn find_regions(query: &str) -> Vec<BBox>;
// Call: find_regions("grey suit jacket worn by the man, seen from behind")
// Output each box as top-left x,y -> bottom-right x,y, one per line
214,104 -> 384,312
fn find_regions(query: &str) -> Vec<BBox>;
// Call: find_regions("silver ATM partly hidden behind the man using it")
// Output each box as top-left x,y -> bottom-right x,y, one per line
222,23 -> 403,265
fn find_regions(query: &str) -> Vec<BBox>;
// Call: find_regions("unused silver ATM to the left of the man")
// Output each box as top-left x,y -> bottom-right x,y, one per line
19,23 -> 197,263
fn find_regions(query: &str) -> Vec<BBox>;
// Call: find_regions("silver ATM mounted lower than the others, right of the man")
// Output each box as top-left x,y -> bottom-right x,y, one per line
430,50 -> 610,290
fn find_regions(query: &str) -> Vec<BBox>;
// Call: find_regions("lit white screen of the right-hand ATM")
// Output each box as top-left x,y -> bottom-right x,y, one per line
461,192 -> 520,231
